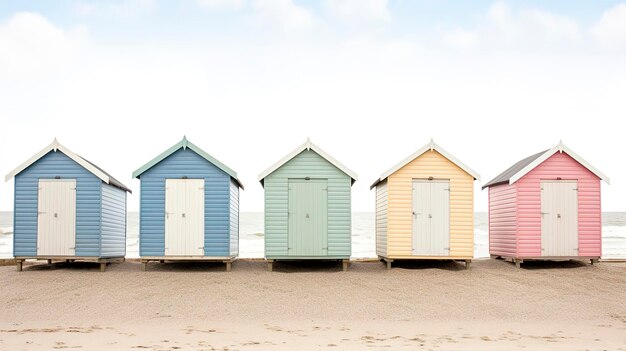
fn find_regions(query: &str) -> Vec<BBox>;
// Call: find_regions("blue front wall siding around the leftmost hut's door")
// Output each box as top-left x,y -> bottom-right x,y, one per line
13,151 -> 102,257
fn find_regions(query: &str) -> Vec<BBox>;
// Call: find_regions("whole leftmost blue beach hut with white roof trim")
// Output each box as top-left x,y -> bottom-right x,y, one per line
6,139 -> 130,271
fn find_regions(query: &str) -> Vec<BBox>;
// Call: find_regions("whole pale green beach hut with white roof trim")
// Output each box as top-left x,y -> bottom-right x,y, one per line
259,140 -> 357,271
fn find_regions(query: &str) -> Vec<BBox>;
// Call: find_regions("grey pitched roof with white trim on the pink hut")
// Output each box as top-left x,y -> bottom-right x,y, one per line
482,142 -> 609,189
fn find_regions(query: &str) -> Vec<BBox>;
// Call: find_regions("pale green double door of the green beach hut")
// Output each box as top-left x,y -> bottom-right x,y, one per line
288,179 -> 328,256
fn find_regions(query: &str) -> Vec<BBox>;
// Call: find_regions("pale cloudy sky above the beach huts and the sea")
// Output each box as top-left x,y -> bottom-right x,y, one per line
0,0 -> 626,212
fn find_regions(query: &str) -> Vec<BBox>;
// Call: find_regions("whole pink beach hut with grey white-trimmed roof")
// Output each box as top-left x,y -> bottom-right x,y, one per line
483,143 -> 609,267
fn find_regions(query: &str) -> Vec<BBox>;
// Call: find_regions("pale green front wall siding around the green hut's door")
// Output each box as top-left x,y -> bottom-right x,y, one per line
264,150 -> 351,258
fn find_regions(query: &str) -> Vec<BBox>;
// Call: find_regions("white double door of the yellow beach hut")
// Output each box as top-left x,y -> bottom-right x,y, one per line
413,180 -> 450,256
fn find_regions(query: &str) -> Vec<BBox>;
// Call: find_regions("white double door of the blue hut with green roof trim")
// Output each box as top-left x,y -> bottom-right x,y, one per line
165,179 -> 204,256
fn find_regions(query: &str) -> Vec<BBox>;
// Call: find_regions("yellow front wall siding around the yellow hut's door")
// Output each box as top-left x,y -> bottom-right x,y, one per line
387,150 -> 474,258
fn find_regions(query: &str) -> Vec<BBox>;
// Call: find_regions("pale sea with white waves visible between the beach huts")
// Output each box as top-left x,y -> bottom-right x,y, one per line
0,212 -> 626,259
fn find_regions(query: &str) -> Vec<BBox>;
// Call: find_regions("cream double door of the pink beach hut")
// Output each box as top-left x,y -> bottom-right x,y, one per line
541,180 -> 578,256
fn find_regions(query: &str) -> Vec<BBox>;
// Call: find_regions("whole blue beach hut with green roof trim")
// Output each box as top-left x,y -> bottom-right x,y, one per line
133,137 -> 243,271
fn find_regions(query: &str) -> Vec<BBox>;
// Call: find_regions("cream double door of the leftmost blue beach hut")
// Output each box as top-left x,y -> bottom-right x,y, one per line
37,179 -> 76,256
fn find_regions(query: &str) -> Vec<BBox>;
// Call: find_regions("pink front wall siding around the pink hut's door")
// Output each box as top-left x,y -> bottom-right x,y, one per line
515,153 -> 602,257
